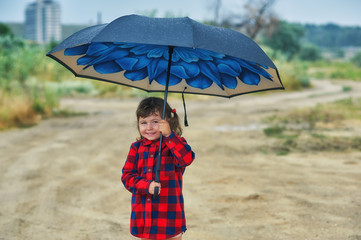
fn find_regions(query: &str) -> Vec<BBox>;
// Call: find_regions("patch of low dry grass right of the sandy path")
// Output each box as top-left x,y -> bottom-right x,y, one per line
263,98 -> 361,155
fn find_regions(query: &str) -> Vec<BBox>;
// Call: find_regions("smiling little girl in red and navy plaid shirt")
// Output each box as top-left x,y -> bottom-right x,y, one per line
122,97 -> 194,240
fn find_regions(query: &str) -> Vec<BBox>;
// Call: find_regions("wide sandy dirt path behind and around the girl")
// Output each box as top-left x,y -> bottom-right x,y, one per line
0,81 -> 361,240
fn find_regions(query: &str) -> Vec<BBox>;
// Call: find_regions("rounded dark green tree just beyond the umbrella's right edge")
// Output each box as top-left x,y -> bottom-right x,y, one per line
264,21 -> 305,60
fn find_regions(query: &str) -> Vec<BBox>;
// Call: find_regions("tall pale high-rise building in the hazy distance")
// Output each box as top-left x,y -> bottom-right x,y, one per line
24,0 -> 62,44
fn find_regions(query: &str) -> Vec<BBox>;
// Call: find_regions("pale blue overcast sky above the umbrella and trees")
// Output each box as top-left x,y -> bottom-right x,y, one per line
0,0 -> 361,26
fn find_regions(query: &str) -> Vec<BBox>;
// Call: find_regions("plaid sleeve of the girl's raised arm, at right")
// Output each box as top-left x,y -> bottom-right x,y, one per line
165,132 -> 195,167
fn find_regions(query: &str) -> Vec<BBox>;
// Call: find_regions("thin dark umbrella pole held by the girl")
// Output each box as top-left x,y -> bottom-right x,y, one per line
154,46 -> 174,199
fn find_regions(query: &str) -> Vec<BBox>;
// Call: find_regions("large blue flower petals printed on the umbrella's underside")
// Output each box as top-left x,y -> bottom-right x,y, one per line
64,42 -> 273,90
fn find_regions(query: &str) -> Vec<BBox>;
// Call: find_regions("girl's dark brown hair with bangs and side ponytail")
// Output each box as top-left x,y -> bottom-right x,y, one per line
136,97 -> 182,139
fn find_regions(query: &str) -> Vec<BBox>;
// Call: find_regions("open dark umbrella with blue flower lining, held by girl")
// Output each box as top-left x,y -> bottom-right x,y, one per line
47,15 -> 284,198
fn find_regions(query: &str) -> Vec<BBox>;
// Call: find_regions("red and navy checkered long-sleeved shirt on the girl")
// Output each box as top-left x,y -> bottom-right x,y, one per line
122,132 -> 194,239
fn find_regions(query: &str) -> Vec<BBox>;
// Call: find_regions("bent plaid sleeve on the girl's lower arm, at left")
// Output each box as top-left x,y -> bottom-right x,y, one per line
122,142 -> 151,195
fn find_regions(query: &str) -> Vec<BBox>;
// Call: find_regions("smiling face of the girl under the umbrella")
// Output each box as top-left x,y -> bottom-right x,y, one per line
138,114 -> 162,141
